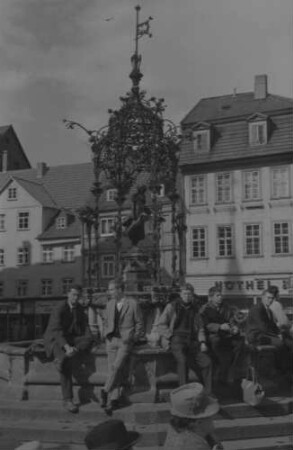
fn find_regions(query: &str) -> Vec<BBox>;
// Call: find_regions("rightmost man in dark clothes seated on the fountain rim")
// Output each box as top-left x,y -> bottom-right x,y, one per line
247,289 -> 293,372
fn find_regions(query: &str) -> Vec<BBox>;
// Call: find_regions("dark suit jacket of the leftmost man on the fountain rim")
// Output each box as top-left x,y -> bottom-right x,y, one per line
44,301 -> 91,357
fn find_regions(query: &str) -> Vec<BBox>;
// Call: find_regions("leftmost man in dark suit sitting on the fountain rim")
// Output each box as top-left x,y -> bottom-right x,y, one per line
44,285 -> 92,413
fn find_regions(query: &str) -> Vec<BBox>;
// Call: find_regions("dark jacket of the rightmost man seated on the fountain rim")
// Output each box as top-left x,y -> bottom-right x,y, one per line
246,303 -> 280,344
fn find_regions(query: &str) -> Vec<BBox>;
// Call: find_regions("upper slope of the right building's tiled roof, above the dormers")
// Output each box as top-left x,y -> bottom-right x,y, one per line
181,92 -> 293,126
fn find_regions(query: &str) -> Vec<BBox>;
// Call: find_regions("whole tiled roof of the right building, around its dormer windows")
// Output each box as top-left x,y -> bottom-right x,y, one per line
180,93 -> 293,168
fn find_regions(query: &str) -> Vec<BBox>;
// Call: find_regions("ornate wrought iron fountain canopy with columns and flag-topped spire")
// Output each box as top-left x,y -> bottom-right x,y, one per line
65,6 -> 181,284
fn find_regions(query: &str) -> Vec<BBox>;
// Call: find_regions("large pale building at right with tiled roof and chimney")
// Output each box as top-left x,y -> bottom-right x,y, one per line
180,75 -> 293,307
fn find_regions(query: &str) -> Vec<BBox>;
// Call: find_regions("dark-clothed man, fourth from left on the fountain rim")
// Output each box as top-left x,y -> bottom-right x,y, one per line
201,286 -> 245,384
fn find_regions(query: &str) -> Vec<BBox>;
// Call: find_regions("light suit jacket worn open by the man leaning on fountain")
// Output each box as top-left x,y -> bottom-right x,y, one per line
105,297 -> 144,344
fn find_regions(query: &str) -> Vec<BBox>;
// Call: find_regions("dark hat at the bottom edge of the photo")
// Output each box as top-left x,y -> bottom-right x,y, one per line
84,419 -> 140,450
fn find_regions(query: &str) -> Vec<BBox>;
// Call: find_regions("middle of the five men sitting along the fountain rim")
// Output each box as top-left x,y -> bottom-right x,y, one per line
157,284 -> 212,393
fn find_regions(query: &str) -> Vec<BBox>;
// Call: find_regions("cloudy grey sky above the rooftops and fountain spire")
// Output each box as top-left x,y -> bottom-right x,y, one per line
0,0 -> 293,167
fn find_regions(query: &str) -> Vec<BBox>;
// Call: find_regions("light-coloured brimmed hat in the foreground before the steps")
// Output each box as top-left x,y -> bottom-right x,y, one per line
170,383 -> 220,419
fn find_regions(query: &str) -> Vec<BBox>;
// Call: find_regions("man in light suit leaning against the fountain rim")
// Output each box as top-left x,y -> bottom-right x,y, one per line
101,280 -> 143,415
